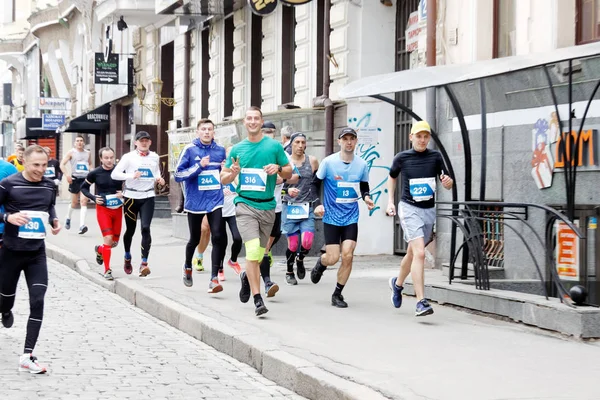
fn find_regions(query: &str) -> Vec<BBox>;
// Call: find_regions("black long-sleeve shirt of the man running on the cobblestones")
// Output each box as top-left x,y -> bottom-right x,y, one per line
0,172 -> 57,251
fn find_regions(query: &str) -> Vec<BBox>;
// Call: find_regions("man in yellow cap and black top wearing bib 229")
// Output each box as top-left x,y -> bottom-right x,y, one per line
387,121 -> 454,317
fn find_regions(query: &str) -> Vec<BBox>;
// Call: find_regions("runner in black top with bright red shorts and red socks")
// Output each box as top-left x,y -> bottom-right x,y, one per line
81,147 -> 123,281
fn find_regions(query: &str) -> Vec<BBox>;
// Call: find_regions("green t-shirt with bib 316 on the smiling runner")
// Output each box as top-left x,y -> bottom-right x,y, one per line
225,136 -> 290,210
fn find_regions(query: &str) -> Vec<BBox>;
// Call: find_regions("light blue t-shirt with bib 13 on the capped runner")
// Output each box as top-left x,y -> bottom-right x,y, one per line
317,152 -> 369,226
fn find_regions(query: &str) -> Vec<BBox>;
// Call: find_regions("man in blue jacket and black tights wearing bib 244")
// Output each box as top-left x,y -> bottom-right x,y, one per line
175,119 -> 227,293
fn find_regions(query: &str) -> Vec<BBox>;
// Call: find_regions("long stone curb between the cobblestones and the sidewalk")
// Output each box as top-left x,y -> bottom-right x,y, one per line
46,243 -> 389,400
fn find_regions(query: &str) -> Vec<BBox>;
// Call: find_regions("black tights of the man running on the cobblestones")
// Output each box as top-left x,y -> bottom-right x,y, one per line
0,246 -> 48,353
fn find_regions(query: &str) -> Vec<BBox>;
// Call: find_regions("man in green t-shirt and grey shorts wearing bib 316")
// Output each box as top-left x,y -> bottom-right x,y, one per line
221,107 -> 292,316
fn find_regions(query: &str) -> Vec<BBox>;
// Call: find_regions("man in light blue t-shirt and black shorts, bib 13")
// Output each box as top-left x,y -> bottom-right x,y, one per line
310,128 -> 375,308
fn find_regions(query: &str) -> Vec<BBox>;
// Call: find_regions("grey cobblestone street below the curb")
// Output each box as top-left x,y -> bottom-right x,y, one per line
0,260 -> 302,400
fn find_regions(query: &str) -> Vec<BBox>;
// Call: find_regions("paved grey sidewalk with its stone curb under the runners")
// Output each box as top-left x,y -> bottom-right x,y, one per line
48,204 -> 600,400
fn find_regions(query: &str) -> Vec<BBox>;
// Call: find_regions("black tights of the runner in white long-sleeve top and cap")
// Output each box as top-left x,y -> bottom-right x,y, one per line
123,197 -> 154,259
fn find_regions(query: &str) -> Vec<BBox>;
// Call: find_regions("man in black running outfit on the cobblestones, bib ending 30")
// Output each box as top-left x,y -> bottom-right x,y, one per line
0,145 -> 61,374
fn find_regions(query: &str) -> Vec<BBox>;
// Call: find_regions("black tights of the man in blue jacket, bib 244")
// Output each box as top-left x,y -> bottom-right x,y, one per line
185,208 -> 227,279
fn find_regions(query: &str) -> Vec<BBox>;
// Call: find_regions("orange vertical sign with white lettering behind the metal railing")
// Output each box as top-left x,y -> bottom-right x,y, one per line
554,221 -> 579,281
